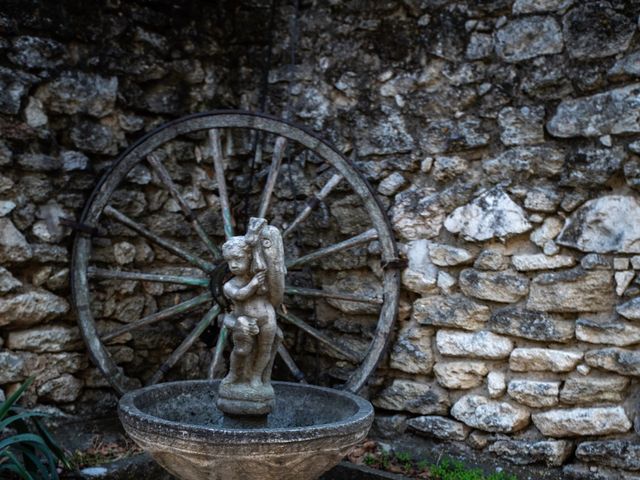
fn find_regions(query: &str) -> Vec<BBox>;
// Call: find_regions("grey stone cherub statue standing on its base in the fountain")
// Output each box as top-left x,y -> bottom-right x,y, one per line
217,218 -> 286,415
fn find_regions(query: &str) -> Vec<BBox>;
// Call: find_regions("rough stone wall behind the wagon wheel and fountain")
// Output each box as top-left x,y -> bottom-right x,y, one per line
0,0 -> 640,478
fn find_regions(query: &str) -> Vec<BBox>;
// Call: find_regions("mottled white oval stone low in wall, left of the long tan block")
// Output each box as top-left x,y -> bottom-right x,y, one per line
451,395 -> 529,433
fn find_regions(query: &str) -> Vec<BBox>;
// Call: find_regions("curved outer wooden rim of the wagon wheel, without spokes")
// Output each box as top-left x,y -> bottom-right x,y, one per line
71,111 -> 400,394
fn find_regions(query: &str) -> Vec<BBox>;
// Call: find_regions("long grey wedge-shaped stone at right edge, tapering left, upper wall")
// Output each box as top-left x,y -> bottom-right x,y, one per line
547,83 -> 640,138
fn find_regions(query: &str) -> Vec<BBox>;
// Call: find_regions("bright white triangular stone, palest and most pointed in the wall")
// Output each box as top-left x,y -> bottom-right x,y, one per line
444,188 -> 531,241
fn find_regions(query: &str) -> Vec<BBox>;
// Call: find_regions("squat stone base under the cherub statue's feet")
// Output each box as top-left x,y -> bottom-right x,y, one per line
216,381 -> 276,415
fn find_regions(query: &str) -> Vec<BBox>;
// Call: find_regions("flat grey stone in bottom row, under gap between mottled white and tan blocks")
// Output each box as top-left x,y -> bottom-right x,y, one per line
488,440 -> 573,467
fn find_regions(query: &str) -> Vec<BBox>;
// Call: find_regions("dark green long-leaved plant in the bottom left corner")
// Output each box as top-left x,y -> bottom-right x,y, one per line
0,377 -> 69,480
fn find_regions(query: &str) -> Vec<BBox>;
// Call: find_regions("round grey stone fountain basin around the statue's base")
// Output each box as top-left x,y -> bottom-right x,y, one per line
119,380 -> 373,480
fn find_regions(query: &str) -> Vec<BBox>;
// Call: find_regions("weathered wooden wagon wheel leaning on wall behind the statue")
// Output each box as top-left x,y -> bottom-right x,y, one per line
71,111 -> 399,393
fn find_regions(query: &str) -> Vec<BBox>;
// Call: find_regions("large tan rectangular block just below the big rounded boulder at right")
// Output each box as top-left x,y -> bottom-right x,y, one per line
527,267 -> 615,312
